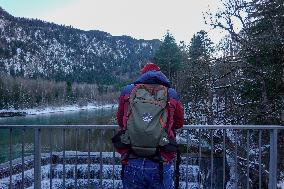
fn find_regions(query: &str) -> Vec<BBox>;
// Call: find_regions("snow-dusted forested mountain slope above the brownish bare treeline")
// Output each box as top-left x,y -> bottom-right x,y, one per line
0,8 -> 160,84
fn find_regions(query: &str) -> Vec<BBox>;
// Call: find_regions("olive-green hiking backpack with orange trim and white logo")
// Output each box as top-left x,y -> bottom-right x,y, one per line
121,84 -> 169,157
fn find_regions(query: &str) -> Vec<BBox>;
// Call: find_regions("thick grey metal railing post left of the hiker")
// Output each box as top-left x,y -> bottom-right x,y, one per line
34,128 -> 41,189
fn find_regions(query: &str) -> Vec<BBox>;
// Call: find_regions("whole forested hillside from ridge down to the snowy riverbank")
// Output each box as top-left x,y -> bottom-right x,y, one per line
0,7 -> 160,109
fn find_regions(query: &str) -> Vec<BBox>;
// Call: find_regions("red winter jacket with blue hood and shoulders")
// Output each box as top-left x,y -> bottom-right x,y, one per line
116,71 -> 184,162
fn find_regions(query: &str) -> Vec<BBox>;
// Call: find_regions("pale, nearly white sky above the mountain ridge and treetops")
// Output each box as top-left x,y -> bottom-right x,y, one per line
0,0 -> 224,43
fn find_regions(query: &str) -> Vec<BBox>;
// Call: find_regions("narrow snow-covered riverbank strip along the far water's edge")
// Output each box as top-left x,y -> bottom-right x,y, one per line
0,103 -> 117,117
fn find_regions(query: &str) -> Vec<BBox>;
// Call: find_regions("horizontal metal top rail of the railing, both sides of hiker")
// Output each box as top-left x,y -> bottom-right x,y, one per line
0,125 -> 284,130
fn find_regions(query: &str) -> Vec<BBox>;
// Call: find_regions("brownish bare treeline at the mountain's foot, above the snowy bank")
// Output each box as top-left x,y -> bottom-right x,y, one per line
0,73 -> 117,109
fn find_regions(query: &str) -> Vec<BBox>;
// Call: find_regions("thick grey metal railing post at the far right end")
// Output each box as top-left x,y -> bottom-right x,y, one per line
269,129 -> 278,189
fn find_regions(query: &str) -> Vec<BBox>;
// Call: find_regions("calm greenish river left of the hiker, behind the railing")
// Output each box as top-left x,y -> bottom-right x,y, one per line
0,108 -> 116,163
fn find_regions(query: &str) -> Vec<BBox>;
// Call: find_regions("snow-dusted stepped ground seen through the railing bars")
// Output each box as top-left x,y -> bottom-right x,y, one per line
0,151 -> 200,189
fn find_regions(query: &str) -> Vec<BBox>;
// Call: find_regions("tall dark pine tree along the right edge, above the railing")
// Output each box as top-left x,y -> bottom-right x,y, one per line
244,0 -> 284,124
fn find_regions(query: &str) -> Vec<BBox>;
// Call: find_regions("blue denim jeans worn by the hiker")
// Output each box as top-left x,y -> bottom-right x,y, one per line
122,159 -> 173,189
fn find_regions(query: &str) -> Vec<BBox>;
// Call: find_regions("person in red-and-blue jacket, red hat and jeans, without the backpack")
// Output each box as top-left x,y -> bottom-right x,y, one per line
116,63 -> 184,189
